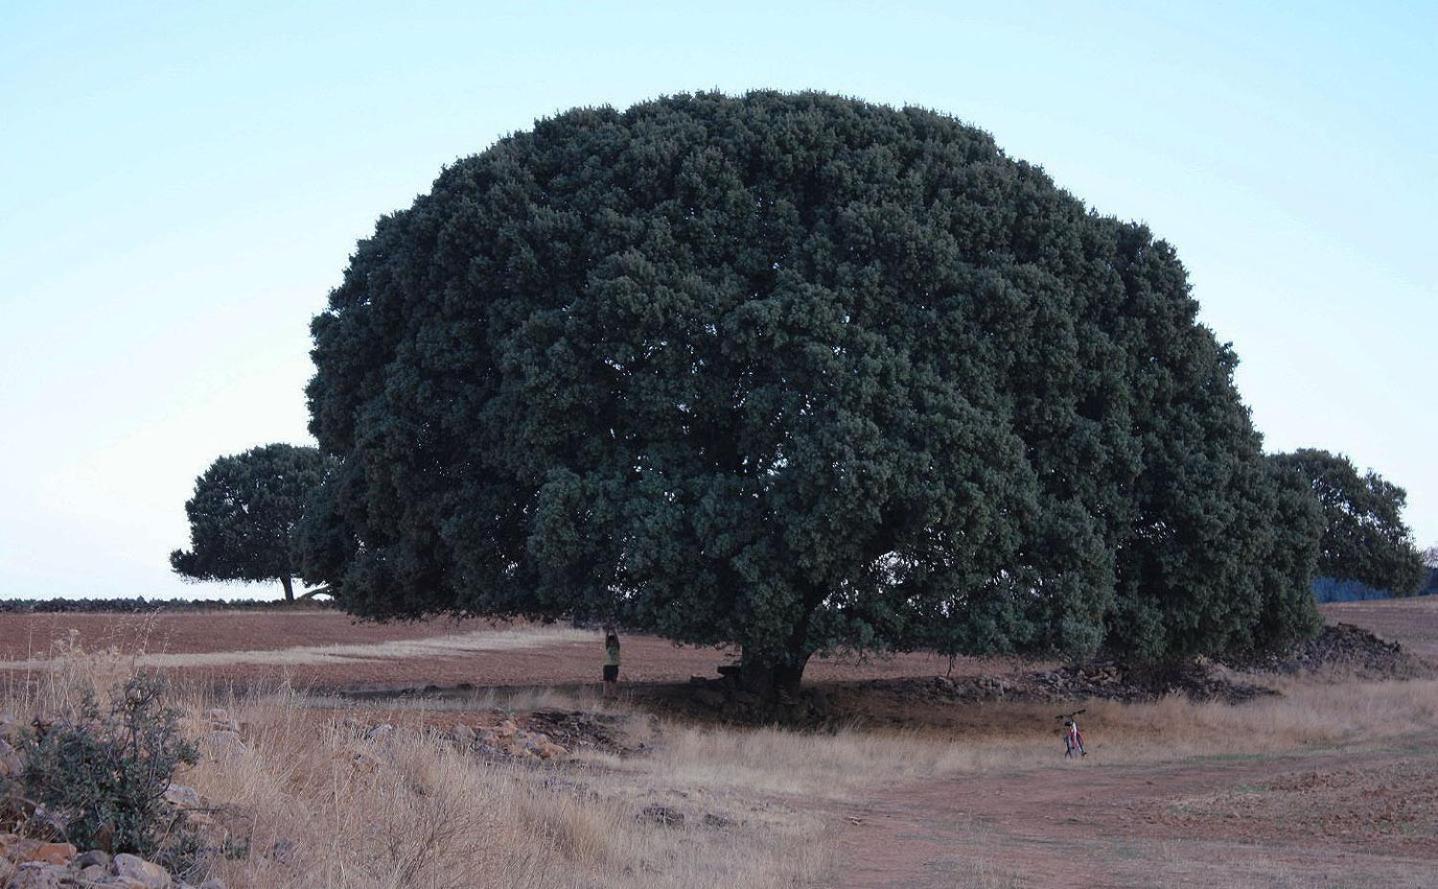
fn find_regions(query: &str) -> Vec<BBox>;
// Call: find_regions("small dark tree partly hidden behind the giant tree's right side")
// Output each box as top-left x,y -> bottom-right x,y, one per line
1273,447 -> 1425,596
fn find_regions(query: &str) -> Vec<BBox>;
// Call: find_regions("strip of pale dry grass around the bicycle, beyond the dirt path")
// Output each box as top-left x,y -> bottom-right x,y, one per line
580,680 -> 1438,801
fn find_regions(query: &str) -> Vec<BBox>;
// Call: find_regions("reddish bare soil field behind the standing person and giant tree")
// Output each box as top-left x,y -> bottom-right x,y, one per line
0,608 -> 982,692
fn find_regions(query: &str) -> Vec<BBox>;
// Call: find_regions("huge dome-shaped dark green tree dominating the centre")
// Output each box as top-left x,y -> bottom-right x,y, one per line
302,92 -> 1317,682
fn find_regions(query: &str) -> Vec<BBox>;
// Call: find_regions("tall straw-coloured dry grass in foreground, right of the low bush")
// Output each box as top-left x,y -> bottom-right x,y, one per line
184,696 -> 820,889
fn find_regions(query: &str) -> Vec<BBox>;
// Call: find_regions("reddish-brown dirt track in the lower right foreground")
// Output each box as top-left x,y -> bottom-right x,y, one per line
827,741 -> 1438,889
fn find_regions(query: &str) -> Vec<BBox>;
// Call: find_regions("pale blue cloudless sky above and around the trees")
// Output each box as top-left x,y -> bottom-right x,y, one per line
0,0 -> 1438,597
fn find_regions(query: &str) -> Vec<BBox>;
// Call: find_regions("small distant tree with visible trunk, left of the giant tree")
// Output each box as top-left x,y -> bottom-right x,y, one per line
170,445 -> 332,601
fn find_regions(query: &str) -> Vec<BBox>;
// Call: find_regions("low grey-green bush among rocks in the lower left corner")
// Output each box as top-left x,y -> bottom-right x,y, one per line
22,676 -> 198,867
